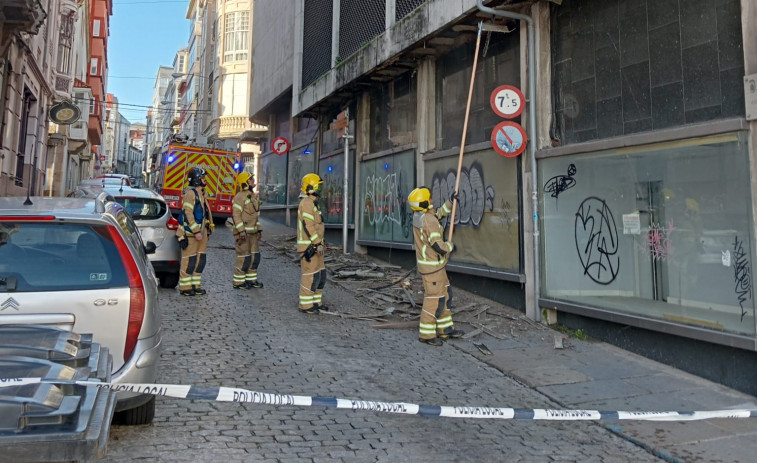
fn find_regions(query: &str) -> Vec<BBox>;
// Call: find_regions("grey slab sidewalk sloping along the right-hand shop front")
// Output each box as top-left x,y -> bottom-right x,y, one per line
261,219 -> 757,462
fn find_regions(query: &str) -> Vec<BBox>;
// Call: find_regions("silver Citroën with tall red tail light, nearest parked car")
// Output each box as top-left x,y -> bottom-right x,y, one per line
0,193 -> 161,424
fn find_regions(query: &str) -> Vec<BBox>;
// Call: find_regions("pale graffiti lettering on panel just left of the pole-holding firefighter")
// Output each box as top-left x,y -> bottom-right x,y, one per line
363,172 -> 413,238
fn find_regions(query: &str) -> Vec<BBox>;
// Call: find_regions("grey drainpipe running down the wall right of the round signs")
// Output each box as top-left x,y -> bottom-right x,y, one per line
476,0 -> 541,321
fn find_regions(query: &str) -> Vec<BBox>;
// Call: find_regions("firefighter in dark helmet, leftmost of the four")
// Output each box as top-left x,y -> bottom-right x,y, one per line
176,167 -> 214,296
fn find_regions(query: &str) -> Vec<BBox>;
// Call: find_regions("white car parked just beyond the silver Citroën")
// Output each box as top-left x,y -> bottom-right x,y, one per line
69,184 -> 181,288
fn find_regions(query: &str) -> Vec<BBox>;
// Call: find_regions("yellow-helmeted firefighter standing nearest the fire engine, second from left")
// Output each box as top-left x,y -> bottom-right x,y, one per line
232,172 -> 263,289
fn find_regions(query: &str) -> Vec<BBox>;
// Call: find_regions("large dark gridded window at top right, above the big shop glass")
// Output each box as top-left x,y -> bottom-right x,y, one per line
551,0 -> 744,145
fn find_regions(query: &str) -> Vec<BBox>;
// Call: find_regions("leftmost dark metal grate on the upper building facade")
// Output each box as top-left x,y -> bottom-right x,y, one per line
302,0 -> 333,88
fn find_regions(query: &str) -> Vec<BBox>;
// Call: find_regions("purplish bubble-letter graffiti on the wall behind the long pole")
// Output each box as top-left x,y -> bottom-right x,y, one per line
431,162 -> 495,228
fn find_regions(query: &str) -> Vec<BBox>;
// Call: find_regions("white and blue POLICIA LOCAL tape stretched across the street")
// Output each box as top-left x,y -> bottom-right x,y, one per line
0,378 -> 757,421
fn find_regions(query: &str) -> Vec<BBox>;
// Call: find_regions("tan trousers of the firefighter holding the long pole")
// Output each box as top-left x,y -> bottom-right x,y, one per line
418,269 -> 455,339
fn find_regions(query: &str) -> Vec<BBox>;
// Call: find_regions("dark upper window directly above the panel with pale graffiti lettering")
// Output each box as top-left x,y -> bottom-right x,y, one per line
370,71 -> 418,152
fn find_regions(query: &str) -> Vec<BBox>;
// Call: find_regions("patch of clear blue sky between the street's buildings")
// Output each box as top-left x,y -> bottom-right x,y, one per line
106,0 -> 189,123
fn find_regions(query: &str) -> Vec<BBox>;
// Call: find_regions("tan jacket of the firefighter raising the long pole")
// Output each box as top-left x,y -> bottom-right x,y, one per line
413,201 -> 453,275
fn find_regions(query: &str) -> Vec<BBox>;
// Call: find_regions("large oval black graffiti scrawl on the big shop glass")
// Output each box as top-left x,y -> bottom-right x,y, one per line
575,196 -> 620,285
